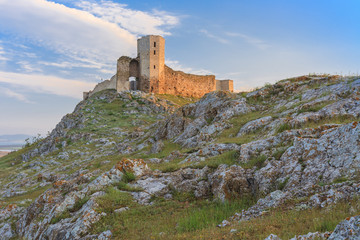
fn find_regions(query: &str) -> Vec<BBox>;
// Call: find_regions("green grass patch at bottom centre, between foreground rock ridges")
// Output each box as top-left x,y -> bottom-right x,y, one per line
91,188 -> 253,239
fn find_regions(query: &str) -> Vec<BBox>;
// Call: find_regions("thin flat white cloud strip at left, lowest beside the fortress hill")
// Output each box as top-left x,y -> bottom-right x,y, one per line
0,72 -> 96,99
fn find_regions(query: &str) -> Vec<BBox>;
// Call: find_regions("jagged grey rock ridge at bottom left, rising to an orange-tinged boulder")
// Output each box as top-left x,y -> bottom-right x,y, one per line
16,159 -> 148,239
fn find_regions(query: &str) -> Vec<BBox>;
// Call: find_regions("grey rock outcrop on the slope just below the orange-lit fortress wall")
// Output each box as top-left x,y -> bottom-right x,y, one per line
155,92 -> 255,147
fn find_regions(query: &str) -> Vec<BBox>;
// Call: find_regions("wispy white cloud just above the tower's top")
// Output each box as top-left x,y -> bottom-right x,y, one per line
75,1 -> 179,35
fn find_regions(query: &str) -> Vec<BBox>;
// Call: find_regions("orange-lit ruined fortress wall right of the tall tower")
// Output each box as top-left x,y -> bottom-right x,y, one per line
164,65 -> 216,98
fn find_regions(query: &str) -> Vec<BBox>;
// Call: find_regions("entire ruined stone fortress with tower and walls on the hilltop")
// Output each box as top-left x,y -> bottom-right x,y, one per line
84,35 -> 234,99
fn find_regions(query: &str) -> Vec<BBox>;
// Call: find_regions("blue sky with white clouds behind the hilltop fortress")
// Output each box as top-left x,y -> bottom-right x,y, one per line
0,0 -> 360,135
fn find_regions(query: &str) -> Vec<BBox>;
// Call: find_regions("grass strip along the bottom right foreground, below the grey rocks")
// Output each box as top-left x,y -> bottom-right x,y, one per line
170,199 -> 360,240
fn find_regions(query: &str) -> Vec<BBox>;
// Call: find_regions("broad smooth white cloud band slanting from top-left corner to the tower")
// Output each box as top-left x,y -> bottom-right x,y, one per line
0,0 -> 136,72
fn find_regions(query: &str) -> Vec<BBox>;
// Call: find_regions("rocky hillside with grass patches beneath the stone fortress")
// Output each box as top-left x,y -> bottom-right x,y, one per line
0,76 -> 360,239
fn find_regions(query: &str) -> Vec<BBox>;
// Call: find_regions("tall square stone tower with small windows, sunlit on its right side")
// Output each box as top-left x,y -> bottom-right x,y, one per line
137,35 -> 165,93
